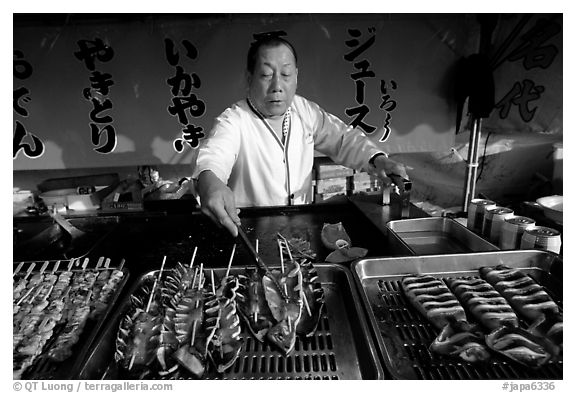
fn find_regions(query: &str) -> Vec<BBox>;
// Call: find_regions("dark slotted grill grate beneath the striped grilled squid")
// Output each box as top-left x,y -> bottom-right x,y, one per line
365,276 -> 562,379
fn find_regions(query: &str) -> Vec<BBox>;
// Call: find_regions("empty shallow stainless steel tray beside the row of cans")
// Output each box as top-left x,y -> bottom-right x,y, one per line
386,217 -> 499,255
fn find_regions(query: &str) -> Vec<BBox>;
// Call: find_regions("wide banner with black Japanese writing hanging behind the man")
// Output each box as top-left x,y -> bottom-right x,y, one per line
13,14 -> 532,170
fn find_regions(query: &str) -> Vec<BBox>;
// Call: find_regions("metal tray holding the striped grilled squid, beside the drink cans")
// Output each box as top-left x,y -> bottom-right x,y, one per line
352,250 -> 562,379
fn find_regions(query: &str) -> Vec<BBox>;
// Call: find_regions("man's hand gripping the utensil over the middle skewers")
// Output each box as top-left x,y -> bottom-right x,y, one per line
197,171 -> 240,237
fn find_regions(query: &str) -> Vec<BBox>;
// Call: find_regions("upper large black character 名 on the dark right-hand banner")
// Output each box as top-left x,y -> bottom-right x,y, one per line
507,20 -> 562,70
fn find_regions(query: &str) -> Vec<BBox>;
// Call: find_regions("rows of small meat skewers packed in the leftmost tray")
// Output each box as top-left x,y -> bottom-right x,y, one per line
12,258 -> 124,378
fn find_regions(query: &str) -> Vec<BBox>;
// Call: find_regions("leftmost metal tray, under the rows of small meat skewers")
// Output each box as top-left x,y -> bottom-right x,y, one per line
14,258 -> 129,379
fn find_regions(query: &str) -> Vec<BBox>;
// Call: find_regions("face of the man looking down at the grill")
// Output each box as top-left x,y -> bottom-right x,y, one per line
248,45 -> 298,118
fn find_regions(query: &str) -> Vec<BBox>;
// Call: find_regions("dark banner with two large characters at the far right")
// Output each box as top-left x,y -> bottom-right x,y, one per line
483,14 -> 563,134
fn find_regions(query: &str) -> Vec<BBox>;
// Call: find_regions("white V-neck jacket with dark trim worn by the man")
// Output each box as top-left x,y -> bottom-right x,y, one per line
192,95 -> 382,207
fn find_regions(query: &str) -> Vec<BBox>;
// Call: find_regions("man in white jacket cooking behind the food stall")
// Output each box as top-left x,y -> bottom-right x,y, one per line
192,34 -> 408,236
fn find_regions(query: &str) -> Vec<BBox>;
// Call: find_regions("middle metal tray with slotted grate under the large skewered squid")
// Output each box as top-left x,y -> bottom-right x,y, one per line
80,264 -> 384,380
